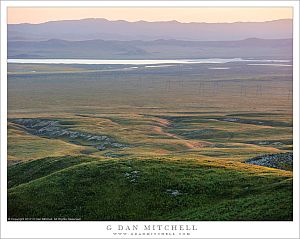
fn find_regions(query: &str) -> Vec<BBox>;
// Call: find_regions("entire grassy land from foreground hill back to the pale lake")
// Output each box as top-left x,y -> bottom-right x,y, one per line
8,62 -> 293,220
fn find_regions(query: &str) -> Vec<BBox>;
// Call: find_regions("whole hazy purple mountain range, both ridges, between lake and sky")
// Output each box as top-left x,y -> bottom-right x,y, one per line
8,19 -> 293,59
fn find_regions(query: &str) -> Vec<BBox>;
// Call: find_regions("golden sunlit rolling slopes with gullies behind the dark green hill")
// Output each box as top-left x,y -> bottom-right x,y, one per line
8,110 -> 293,162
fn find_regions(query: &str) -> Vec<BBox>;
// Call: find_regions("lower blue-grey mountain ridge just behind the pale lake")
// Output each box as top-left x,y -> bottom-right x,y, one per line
8,38 -> 293,59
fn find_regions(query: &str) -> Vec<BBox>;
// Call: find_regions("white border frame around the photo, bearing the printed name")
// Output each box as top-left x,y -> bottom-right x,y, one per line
1,0 -> 299,238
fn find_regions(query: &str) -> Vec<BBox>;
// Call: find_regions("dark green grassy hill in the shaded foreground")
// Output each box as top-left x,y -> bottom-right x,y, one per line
8,157 -> 292,220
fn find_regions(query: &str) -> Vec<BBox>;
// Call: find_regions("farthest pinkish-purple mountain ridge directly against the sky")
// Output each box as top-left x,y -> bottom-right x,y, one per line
8,18 -> 293,41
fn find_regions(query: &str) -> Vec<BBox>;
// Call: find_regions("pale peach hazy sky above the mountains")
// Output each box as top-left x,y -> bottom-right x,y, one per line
7,7 -> 293,23
